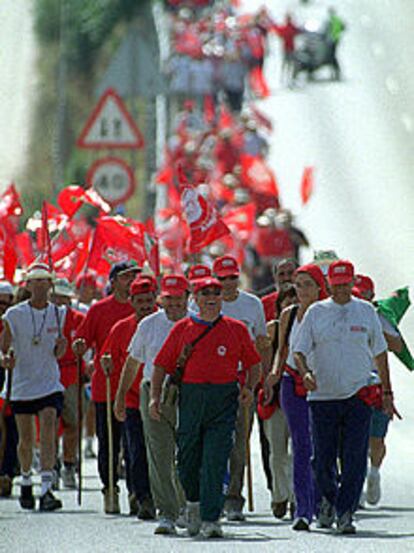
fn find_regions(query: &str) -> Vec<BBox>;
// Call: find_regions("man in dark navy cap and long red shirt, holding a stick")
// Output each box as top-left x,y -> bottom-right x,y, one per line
73,261 -> 140,514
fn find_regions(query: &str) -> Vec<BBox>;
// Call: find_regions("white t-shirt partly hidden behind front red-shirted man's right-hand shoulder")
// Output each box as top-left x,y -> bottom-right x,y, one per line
221,290 -> 267,340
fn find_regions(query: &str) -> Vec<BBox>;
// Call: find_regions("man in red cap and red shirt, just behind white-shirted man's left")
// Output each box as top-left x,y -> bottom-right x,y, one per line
101,275 -> 158,520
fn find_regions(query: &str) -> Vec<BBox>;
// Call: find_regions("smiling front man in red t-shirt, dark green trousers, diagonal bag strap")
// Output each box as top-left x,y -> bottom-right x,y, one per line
150,277 -> 260,538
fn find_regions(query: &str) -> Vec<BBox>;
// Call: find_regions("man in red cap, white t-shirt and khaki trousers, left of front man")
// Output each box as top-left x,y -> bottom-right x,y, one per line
114,275 -> 189,535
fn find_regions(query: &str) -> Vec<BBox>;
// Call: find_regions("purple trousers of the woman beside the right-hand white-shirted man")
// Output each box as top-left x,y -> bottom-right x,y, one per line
281,375 -> 315,523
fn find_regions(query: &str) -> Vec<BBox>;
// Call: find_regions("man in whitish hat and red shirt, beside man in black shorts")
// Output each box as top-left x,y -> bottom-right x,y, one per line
50,278 -> 85,489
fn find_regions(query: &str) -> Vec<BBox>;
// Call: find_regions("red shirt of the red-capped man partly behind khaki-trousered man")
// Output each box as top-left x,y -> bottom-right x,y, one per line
101,314 -> 142,409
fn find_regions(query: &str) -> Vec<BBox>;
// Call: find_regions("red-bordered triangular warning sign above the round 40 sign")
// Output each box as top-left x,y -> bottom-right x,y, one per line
76,88 -> 144,150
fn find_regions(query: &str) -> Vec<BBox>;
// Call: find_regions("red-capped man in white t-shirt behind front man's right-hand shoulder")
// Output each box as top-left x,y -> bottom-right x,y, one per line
213,255 -> 271,521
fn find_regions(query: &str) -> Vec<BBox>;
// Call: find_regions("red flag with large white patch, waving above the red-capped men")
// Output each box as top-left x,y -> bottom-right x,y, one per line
181,185 -> 230,253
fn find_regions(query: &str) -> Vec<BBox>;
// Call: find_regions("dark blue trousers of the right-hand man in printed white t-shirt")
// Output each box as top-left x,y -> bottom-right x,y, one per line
309,396 -> 371,517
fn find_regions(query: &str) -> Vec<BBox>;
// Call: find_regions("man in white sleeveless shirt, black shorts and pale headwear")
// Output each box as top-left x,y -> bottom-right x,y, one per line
1,263 -> 67,511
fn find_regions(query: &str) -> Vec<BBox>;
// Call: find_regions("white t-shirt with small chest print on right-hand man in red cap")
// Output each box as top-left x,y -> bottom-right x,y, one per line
294,298 -> 387,400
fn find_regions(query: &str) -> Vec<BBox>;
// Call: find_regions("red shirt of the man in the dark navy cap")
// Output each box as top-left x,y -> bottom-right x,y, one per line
76,295 -> 134,402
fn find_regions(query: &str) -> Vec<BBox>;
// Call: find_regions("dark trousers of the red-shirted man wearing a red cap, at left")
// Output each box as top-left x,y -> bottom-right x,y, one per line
124,407 -> 151,501
